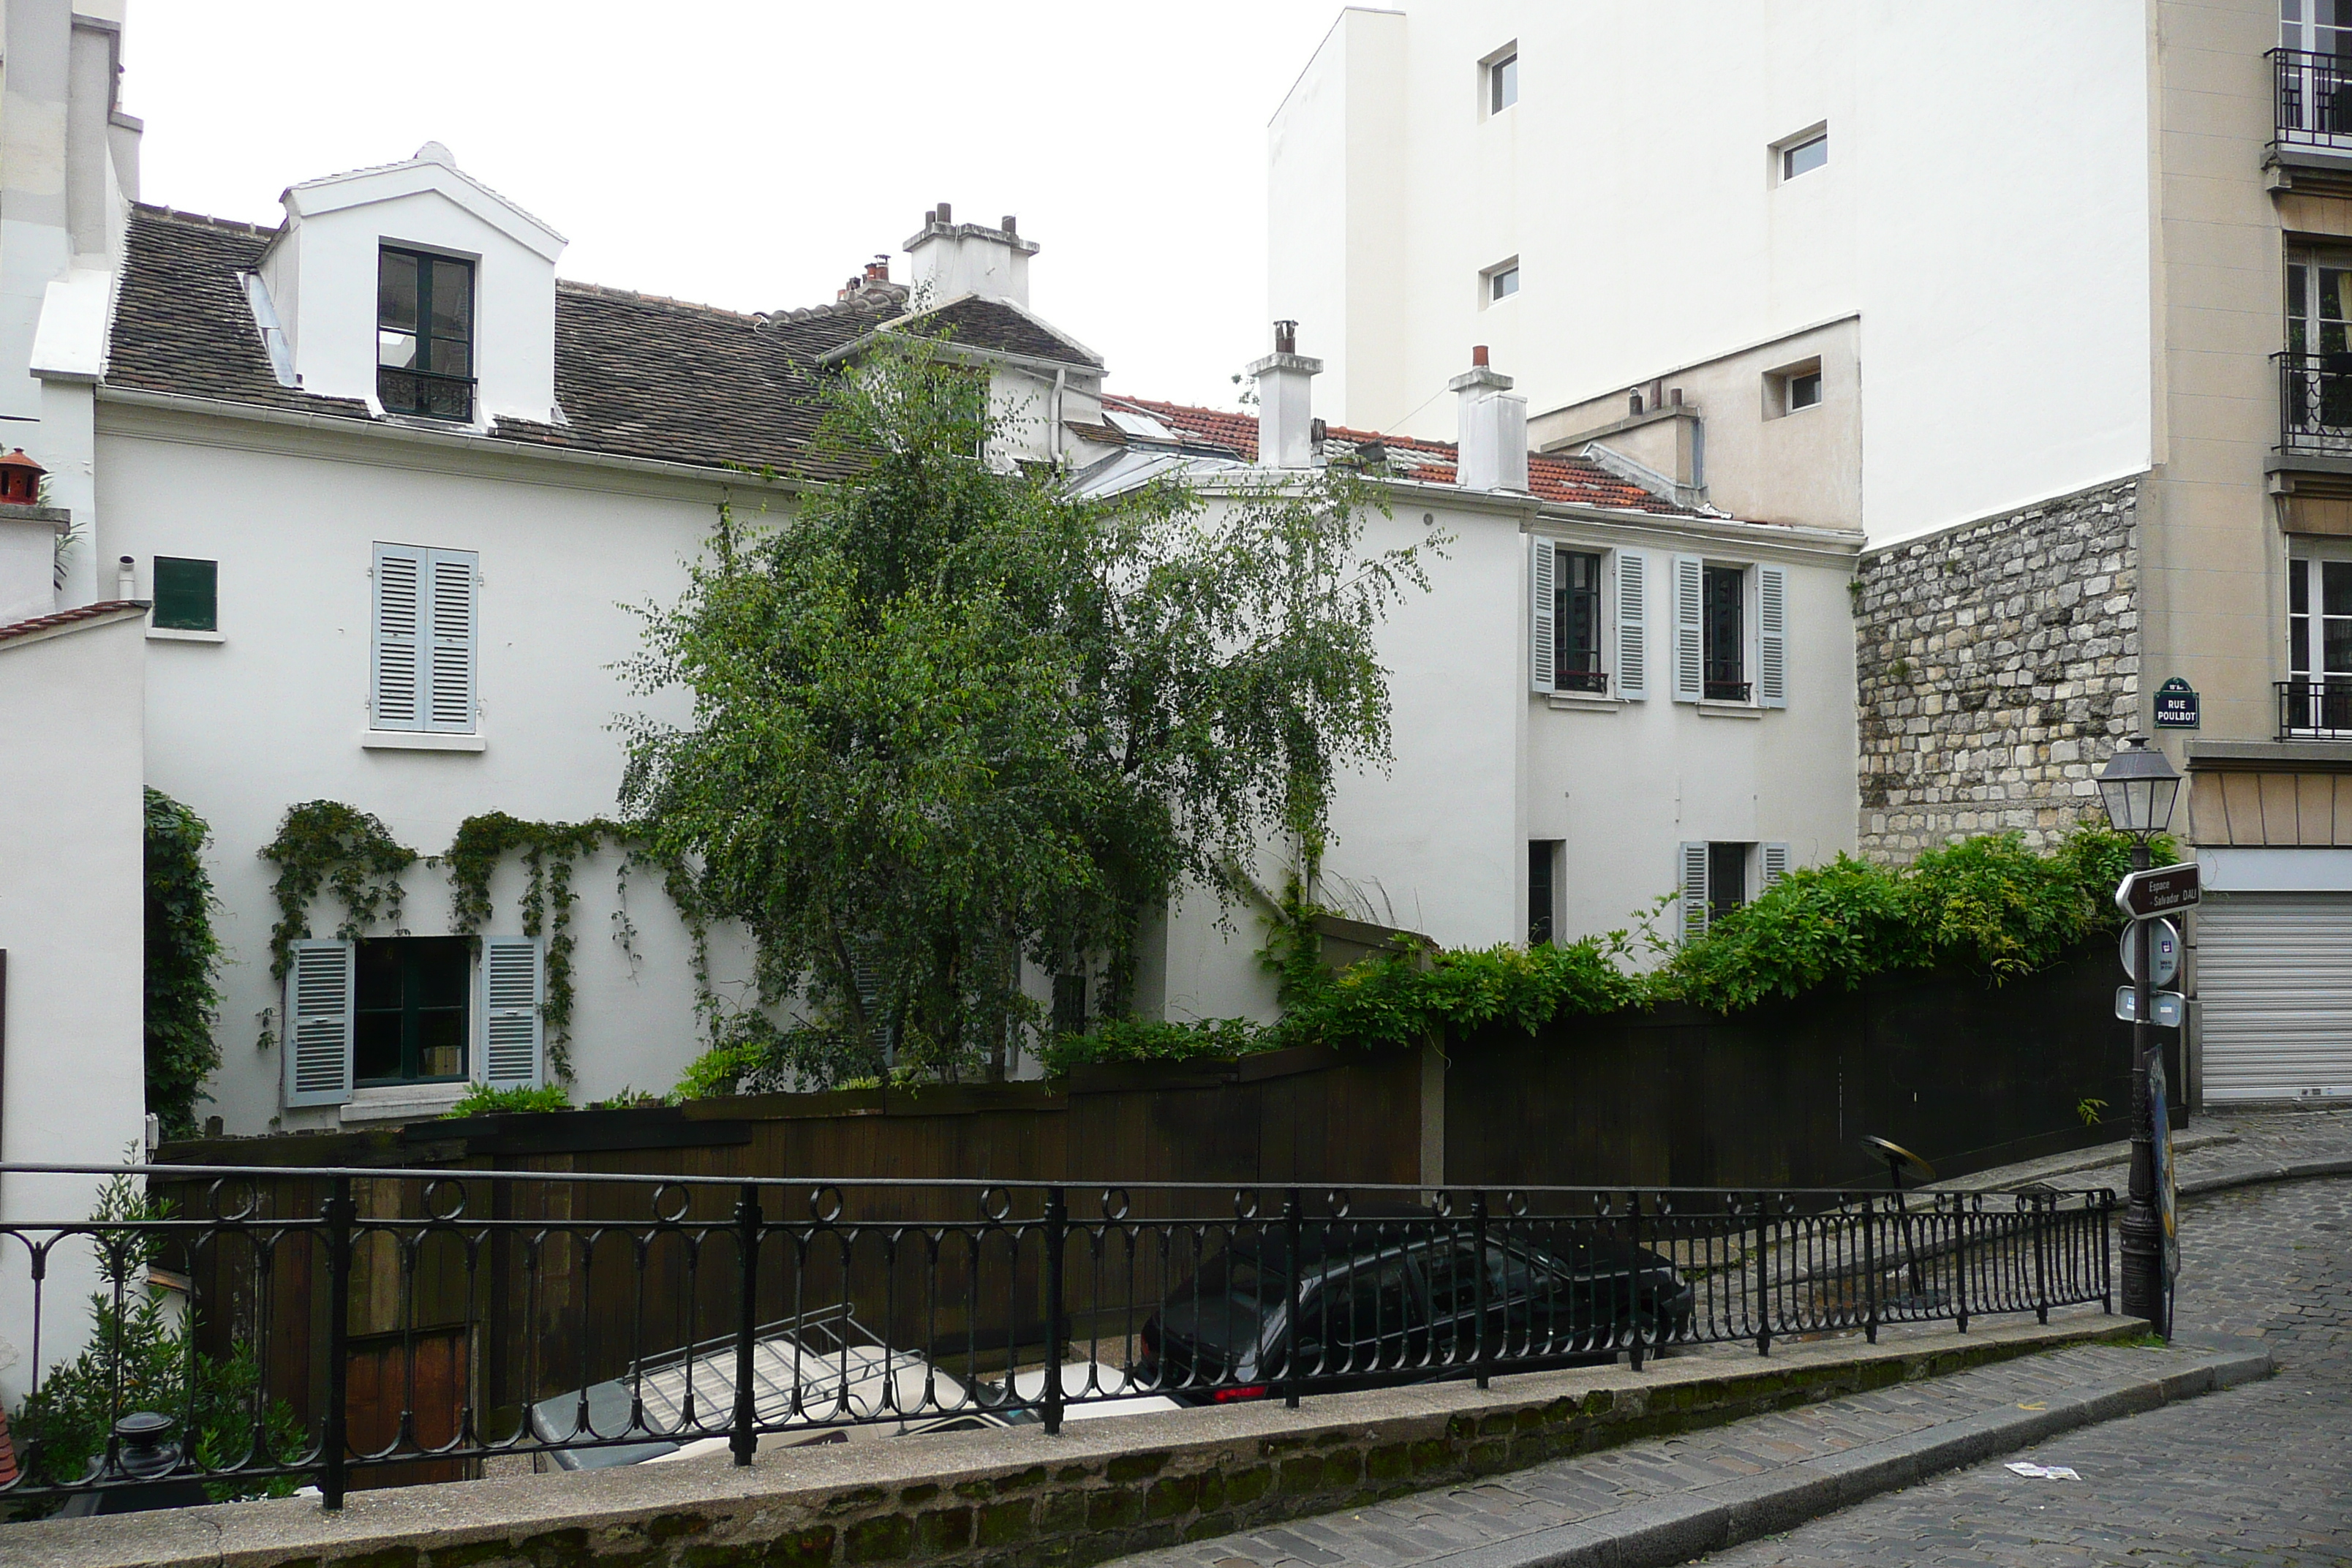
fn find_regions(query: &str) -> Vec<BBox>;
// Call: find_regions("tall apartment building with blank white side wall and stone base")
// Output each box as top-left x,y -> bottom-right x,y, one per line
1267,0 -> 2352,1100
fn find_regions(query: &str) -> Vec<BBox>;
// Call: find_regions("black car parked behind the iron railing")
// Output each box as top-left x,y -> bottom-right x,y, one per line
1136,1210 -> 1694,1403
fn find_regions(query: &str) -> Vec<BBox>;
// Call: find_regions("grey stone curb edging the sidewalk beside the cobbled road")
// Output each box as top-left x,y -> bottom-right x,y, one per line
1364,1354 -> 2277,1568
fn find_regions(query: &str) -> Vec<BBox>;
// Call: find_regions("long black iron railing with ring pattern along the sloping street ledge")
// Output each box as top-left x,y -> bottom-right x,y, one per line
0,1166 -> 2114,1509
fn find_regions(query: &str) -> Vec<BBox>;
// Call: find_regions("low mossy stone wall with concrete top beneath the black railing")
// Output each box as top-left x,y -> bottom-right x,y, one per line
0,1316 -> 2147,1568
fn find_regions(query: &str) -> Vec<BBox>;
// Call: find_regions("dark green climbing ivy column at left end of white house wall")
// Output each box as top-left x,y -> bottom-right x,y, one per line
146,790 -> 221,1138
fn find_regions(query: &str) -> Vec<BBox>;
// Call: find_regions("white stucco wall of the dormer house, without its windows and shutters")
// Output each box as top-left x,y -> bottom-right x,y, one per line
99,404 -> 758,1133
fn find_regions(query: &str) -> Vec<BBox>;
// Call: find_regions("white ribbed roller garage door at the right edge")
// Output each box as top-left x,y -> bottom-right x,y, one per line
2197,893 -> 2352,1100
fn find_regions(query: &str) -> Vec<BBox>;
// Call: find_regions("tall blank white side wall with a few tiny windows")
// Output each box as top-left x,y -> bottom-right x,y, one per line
1267,0 -> 2152,540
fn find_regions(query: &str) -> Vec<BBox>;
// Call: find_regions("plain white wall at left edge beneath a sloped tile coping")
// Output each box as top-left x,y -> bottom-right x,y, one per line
0,616 -> 146,1403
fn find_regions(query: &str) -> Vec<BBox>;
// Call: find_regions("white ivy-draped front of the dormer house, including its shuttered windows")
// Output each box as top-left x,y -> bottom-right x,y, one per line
97,402 -> 758,1133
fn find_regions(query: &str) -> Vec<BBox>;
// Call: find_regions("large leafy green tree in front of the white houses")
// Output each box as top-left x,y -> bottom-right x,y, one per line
623,343 -> 1420,1082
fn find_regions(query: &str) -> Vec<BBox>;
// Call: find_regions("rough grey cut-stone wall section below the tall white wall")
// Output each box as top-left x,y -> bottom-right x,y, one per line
1853,480 -> 2141,860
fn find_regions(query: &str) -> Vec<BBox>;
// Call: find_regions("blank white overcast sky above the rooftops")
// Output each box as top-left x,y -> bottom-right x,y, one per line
122,0 -> 1341,407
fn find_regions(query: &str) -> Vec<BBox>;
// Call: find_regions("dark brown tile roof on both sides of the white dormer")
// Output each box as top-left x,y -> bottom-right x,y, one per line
106,207 -> 908,472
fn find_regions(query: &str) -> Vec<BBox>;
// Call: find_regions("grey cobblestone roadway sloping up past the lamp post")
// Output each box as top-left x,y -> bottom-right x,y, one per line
1703,1185 -> 2352,1568
